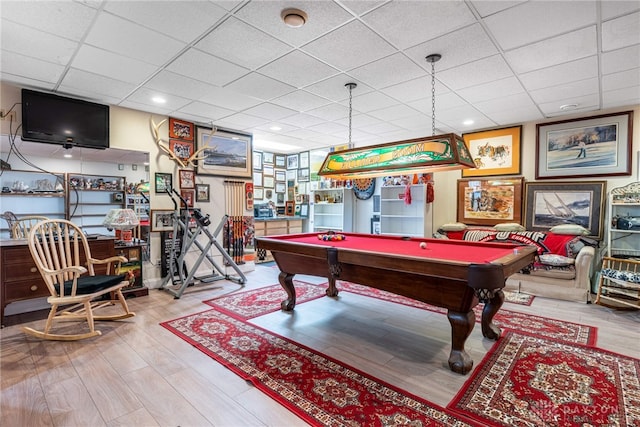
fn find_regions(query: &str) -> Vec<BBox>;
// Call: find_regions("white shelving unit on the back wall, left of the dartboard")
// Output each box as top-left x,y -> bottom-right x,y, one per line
311,188 -> 353,232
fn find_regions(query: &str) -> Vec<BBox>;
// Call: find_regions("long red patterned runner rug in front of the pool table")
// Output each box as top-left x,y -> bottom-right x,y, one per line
161,310 -> 486,426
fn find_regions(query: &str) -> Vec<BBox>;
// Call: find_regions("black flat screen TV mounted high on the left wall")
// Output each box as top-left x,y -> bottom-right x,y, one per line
22,89 -> 109,149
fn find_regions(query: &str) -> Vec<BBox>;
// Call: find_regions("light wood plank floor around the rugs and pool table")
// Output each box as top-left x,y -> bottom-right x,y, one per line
0,265 -> 640,427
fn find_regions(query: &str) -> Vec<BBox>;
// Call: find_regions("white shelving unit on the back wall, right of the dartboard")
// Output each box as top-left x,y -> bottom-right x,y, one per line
380,184 -> 433,237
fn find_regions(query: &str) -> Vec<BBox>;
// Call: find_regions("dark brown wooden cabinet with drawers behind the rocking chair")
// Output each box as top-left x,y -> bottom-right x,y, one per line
0,238 -> 115,324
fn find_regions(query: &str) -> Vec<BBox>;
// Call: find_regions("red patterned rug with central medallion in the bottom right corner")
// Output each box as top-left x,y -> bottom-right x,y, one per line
448,332 -> 640,427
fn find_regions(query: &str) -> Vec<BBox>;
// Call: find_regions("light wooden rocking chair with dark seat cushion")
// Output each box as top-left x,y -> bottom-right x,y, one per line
22,219 -> 135,341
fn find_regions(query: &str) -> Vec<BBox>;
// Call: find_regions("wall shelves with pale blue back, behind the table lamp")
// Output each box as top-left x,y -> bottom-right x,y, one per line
67,174 -> 125,234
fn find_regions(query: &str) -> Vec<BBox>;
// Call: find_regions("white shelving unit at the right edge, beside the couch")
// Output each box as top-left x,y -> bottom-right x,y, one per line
607,182 -> 640,259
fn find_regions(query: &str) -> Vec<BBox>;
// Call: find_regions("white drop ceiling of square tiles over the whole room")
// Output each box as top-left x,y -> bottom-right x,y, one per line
0,0 -> 640,152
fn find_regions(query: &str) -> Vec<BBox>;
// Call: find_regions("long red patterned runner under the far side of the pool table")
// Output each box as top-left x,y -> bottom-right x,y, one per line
205,281 -> 597,345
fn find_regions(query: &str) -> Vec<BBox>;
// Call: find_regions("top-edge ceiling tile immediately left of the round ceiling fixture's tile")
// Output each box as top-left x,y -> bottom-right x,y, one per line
104,0 -> 231,42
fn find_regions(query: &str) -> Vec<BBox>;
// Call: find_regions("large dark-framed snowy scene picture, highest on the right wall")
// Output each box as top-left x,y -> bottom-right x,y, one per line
536,111 -> 633,179
